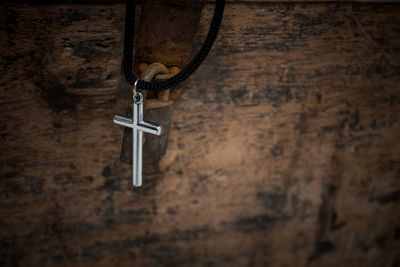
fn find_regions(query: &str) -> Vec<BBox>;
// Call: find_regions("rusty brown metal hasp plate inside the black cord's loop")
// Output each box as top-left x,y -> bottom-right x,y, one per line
134,0 -> 204,76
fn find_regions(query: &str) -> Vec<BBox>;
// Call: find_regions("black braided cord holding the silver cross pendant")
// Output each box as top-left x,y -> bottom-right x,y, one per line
123,0 -> 225,91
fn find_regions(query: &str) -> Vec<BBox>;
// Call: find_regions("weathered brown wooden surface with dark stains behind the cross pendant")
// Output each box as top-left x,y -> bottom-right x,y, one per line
0,3 -> 400,266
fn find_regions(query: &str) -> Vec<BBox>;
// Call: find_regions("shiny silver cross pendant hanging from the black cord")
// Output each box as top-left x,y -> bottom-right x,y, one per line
114,93 -> 161,186
